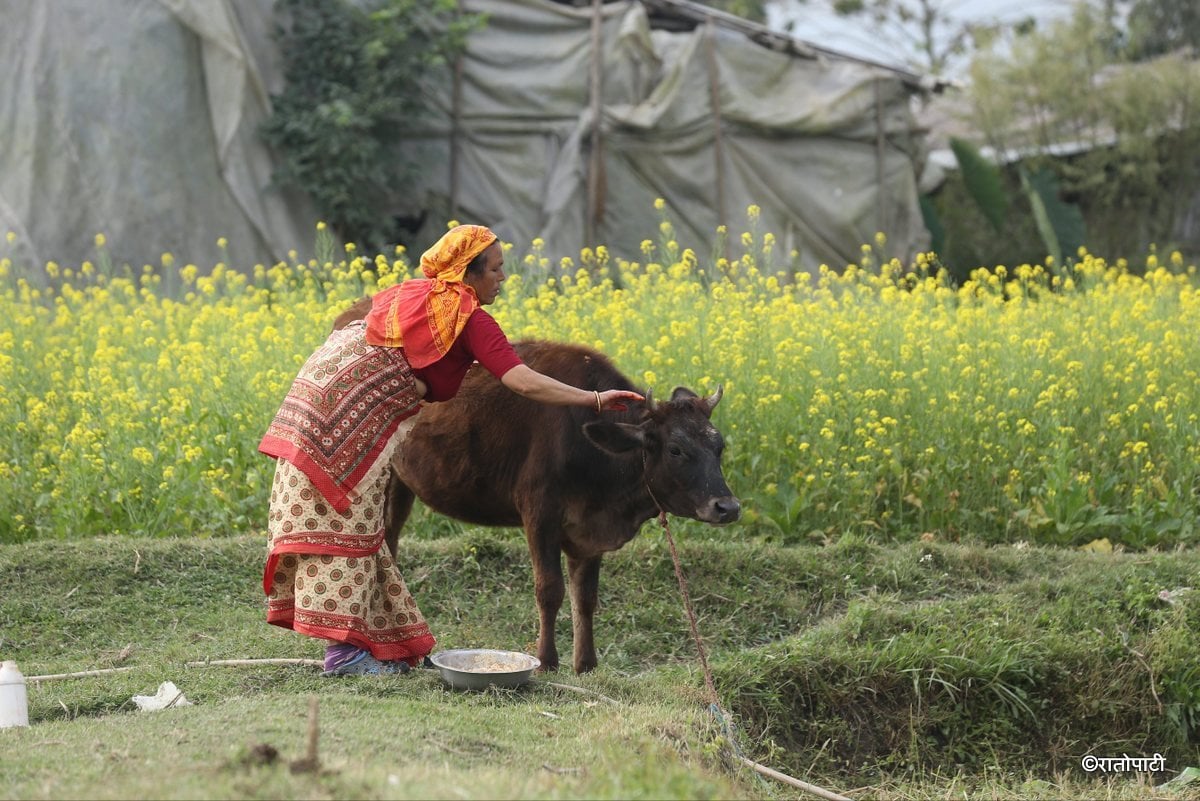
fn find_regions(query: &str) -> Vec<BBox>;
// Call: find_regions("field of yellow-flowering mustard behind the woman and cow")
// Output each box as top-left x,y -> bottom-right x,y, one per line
0,207 -> 1200,549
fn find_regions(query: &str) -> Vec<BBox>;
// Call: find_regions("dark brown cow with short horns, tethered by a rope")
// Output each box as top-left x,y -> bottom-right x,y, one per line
386,342 -> 742,673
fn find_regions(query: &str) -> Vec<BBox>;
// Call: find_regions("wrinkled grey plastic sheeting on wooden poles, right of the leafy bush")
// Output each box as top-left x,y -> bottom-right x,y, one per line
404,0 -> 928,270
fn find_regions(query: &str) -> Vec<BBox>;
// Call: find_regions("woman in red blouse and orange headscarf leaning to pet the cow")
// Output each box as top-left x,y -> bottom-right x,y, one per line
259,225 -> 643,676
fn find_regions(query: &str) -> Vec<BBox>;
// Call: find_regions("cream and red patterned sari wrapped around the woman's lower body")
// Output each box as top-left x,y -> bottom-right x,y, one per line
259,321 -> 436,664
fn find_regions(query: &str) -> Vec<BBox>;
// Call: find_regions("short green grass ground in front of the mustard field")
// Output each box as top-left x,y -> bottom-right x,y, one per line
0,525 -> 1200,799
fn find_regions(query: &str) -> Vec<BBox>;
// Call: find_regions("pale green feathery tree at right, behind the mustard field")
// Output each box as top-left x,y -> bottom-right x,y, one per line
968,2 -> 1200,255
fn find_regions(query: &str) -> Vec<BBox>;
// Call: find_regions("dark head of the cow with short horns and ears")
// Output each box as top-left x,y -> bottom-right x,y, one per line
583,386 -> 742,524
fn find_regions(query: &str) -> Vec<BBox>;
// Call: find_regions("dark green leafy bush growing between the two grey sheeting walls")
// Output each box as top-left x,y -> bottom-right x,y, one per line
263,0 -> 482,246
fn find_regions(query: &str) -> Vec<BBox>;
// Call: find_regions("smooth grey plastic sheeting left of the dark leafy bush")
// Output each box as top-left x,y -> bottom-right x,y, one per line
0,0 -> 316,267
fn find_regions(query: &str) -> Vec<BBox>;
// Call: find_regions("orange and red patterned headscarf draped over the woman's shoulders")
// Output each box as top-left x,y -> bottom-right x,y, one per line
366,225 -> 497,369
